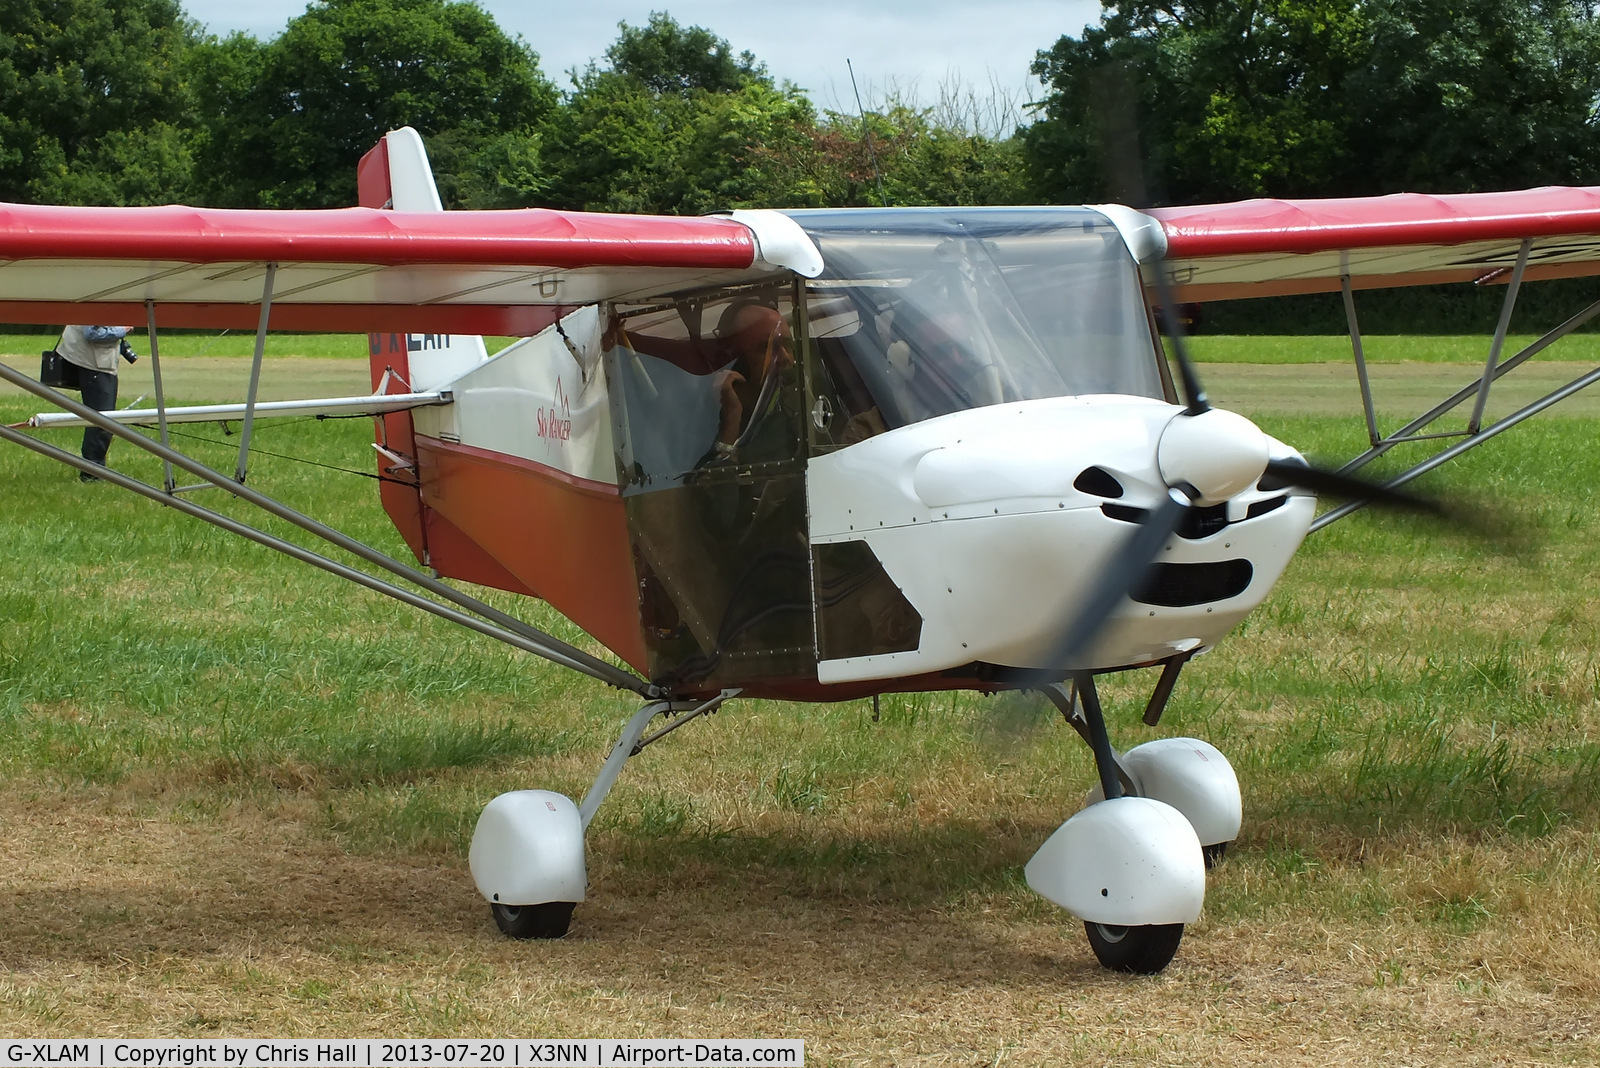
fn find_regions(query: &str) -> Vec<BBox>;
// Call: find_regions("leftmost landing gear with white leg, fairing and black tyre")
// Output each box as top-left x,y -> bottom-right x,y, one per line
467,689 -> 739,938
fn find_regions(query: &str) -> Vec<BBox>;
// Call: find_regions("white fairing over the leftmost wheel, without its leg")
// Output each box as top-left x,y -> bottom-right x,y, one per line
467,790 -> 589,905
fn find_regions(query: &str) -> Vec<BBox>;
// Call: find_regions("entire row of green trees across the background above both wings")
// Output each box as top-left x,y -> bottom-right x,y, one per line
0,0 -> 1600,213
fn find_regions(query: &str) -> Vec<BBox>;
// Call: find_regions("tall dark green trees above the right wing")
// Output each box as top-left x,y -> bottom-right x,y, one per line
1022,0 -> 1600,201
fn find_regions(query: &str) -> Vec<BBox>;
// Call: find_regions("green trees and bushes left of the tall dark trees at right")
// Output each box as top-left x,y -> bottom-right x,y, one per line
0,0 -> 1026,214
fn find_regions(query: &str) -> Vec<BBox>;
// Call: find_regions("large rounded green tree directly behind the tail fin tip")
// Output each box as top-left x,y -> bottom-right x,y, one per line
194,0 -> 557,208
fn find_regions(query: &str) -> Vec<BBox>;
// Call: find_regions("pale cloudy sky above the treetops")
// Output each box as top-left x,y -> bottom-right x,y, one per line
175,0 -> 1101,125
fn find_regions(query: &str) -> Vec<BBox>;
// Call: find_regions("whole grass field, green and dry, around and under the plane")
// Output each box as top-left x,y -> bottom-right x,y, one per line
0,346 -> 1600,1065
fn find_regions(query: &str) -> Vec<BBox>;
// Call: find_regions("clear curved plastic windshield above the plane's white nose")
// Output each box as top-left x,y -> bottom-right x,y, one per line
790,208 -> 1163,428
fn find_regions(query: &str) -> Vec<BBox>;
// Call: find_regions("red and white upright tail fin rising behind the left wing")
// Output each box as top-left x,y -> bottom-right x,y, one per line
355,126 -> 488,392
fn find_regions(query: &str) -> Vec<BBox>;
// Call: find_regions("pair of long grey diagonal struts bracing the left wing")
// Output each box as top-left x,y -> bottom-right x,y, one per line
0,363 -> 661,700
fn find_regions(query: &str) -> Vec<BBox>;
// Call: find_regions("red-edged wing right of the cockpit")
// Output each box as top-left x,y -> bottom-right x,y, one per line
1149,185 -> 1600,301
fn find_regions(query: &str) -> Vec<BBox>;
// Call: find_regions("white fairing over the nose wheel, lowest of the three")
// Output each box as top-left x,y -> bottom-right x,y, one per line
1022,798 -> 1205,927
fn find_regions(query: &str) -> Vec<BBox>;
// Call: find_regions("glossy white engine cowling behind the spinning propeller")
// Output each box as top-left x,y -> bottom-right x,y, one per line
806,397 -> 1315,683
